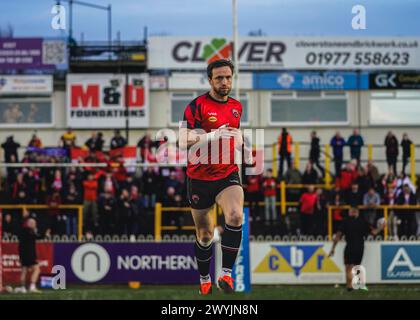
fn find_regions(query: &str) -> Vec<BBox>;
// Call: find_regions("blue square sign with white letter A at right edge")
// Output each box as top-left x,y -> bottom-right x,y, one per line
381,244 -> 420,280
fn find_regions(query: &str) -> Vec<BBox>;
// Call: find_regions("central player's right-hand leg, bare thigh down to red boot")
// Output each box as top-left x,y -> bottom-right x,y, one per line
216,185 -> 244,293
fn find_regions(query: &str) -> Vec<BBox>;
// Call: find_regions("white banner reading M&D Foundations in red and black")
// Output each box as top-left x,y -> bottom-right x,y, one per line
67,74 -> 149,128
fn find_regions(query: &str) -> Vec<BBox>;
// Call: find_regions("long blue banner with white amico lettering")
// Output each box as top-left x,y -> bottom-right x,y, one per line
253,71 -> 369,90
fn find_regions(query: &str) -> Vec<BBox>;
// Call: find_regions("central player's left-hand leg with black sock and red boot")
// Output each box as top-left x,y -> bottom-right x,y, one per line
191,207 -> 214,294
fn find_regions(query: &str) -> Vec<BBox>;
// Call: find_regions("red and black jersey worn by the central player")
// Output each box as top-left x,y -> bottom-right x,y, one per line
184,92 -> 242,181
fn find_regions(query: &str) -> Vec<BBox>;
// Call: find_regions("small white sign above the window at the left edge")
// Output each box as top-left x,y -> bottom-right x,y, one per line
0,75 -> 53,95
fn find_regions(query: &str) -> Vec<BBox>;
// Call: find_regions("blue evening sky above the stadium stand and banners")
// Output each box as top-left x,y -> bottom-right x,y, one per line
0,0 -> 420,40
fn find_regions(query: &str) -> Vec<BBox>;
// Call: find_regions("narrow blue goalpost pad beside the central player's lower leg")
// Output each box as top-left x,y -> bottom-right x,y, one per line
232,208 -> 251,293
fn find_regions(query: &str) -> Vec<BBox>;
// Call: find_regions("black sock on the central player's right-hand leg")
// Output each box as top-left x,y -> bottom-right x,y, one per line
222,224 -> 242,270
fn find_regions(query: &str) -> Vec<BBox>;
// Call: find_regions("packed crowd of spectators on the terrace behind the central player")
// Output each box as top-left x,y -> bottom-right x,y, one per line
0,131 -> 420,239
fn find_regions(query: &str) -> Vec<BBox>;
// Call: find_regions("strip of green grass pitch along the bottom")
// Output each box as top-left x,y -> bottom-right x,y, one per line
0,285 -> 420,300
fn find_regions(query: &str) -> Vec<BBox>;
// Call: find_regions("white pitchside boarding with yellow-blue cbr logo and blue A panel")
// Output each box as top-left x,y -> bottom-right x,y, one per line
250,242 -> 420,286
